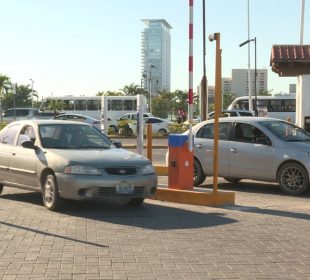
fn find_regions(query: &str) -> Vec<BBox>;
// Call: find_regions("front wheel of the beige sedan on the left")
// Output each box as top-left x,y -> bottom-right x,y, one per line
42,174 -> 62,211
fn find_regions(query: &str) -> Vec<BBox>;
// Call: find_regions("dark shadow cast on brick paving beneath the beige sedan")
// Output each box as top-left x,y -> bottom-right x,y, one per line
1,192 -> 238,230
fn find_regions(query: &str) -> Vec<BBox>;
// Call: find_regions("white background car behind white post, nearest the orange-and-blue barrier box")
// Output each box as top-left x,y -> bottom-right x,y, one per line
128,117 -> 173,136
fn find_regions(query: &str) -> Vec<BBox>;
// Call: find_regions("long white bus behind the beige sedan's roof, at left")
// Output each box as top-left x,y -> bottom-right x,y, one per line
39,95 -> 146,121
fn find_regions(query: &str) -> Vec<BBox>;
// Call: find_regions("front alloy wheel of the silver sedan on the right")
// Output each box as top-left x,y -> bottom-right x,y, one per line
278,162 -> 309,195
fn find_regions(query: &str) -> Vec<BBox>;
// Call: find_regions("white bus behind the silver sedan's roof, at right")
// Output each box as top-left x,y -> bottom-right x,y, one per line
228,94 -> 296,123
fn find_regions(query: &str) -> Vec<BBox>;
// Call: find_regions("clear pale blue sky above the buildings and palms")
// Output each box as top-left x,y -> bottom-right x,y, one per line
0,0 -> 310,98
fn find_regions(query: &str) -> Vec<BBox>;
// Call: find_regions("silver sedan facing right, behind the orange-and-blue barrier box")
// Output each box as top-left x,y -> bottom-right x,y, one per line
167,117 -> 310,195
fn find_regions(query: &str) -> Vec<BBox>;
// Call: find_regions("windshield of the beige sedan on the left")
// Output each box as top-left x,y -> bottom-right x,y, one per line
39,124 -> 112,149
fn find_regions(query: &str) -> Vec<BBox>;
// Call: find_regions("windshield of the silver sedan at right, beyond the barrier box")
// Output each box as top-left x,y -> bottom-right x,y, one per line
260,121 -> 310,142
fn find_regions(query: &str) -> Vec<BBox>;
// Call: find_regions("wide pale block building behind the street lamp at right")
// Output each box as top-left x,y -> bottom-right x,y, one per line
231,69 -> 268,96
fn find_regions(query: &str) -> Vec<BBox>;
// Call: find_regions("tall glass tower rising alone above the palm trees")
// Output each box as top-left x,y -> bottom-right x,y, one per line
141,19 -> 172,96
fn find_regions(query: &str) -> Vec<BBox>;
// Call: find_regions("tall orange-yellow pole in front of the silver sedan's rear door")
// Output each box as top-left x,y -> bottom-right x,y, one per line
213,33 -> 222,194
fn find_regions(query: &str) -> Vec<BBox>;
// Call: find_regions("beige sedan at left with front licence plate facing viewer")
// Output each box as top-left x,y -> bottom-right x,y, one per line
0,120 -> 157,210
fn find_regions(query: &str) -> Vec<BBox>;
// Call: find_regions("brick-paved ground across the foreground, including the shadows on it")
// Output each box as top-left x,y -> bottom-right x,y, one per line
0,182 -> 310,280
